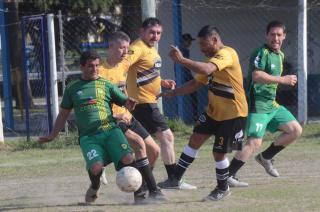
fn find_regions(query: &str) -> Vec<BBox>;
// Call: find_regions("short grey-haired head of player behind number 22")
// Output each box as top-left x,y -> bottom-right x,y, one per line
108,31 -> 130,62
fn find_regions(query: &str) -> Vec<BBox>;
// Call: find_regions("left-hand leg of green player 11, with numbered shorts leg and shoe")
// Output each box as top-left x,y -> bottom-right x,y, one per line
228,113 -> 270,187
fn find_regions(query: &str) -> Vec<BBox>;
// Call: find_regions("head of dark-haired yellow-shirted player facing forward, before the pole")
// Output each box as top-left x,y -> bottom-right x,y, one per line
140,18 -> 162,47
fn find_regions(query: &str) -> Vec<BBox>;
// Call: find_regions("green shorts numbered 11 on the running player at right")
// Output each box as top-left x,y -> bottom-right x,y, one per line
246,106 -> 296,138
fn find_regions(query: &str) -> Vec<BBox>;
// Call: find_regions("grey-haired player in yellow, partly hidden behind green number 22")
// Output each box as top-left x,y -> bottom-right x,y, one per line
99,31 -> 165,202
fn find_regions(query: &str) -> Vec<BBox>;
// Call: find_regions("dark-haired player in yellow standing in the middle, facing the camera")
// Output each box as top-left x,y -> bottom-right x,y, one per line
127,18 -> 196,189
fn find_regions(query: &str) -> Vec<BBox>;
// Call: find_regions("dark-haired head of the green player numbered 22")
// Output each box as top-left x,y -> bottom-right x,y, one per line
80,50 -> 100,80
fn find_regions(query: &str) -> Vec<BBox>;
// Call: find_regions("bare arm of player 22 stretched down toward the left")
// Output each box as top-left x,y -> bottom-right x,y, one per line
38,108 -> 71,144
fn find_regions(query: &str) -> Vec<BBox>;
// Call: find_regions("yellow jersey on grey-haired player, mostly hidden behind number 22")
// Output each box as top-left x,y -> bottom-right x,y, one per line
99,59 -> 132,119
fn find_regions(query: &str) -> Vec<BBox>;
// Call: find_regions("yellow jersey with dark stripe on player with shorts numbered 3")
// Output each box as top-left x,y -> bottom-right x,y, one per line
196,46 -> 248,121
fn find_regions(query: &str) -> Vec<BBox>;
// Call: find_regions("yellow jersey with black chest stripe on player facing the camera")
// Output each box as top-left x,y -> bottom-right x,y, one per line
127,39 -> 161,104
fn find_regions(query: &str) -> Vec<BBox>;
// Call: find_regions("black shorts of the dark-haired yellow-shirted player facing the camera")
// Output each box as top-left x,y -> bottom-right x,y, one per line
132,103 -> 169,134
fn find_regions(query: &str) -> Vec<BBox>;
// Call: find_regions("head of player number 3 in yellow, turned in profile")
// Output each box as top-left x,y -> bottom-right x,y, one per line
198,25 -> 222,57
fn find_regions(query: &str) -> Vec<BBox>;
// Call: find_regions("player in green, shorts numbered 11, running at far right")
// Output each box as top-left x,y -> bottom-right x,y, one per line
228,21 -> 302,187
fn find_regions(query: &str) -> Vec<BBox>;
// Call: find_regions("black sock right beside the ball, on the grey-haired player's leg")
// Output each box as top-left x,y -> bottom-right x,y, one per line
136,157 -> 157,192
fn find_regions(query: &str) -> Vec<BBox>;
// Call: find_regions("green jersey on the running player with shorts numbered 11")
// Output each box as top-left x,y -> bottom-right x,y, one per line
247,45 -> 284,113
